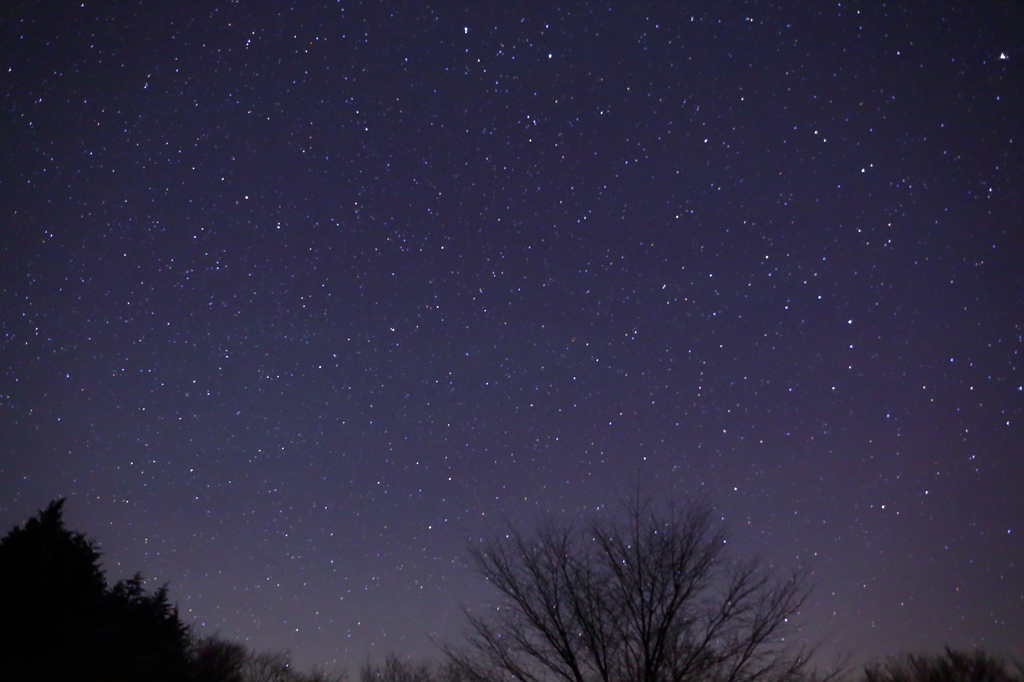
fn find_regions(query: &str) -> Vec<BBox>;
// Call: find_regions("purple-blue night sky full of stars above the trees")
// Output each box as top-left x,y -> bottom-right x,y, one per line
0,0 -> 1024,667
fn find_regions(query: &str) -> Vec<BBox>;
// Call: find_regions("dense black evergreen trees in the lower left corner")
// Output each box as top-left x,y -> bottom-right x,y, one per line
0,500 -> 188,682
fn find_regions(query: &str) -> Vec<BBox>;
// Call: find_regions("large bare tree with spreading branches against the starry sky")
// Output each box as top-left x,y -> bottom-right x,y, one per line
442,495 -> 808,682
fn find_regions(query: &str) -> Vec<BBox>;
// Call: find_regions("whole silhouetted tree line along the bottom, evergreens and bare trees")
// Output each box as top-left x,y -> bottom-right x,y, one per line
0,493 -> 1024,682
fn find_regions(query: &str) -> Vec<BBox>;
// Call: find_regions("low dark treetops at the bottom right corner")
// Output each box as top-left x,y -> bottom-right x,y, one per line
863,646 -> 1024,682
